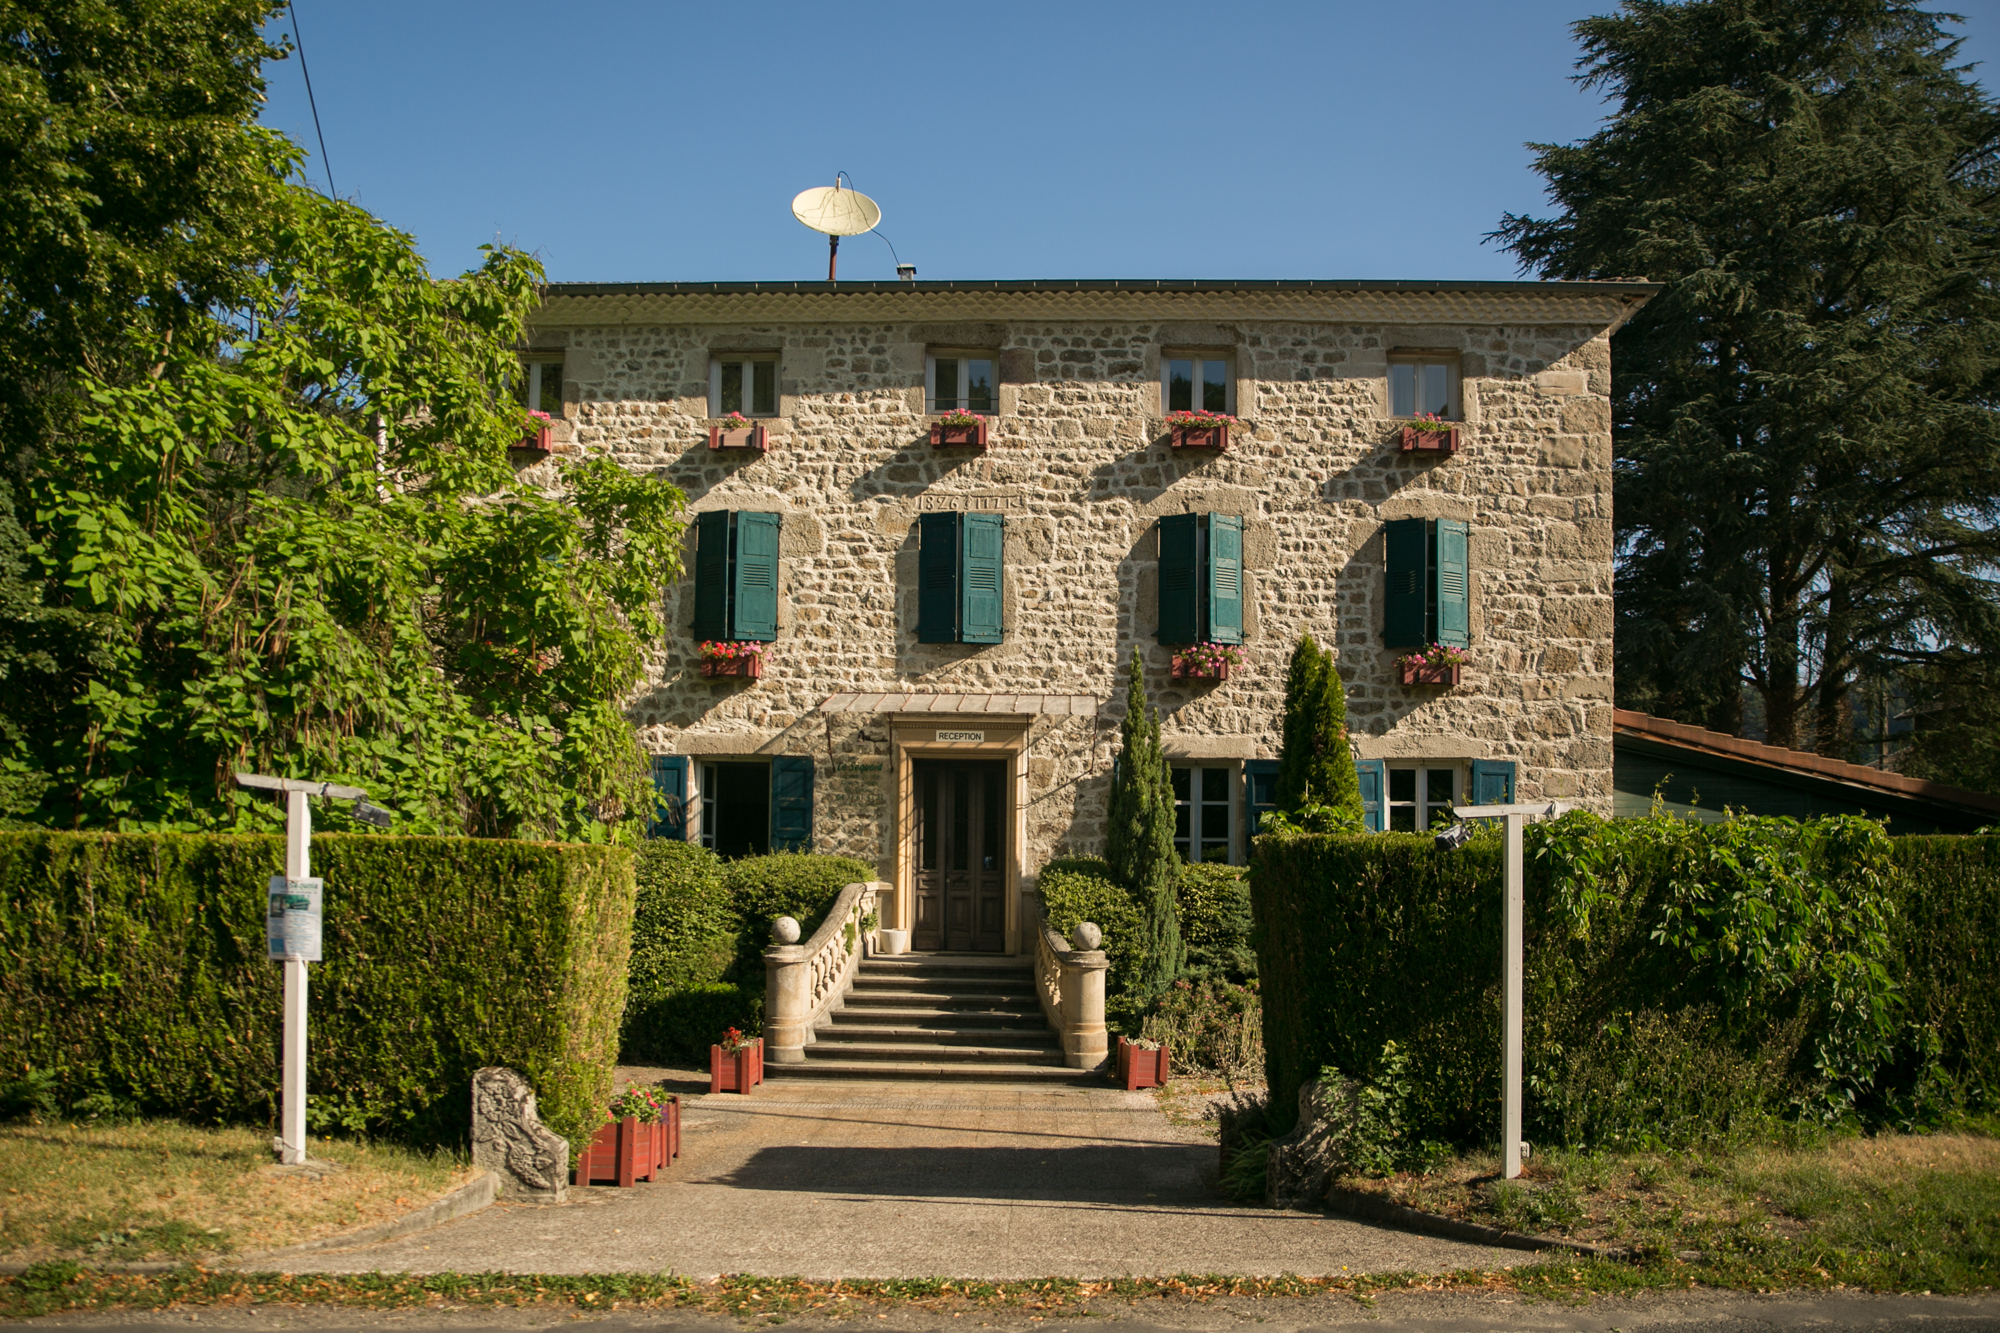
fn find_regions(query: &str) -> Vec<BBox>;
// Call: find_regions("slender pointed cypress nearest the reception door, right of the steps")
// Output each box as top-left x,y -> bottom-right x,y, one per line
1104,648 -> 1188,999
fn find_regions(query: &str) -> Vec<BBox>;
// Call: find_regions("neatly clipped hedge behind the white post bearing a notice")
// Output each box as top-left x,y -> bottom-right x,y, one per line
0,833 -> 634,1147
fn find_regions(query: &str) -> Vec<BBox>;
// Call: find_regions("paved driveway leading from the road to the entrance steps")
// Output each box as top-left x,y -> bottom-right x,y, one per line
246,1081 -> 1532,1279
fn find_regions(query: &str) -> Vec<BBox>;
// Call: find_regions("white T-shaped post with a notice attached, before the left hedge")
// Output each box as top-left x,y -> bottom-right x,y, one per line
236,773 -> 390,1167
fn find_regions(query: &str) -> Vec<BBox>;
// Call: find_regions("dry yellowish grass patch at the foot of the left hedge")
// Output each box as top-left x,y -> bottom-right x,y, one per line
0,1121 -> 472,1263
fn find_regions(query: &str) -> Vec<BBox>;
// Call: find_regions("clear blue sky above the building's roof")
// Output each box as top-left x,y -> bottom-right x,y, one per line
264,0 -> 2000,282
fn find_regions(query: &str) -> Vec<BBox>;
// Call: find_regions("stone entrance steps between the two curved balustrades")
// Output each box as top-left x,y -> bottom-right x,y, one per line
764,953 -> 1102,1083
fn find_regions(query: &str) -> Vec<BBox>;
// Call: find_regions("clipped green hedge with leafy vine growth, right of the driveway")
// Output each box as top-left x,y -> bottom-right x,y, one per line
1250,815 -> 2000,1145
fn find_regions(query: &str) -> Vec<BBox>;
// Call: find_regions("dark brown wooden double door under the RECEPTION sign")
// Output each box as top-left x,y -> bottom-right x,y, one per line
910,761 -> 1010,953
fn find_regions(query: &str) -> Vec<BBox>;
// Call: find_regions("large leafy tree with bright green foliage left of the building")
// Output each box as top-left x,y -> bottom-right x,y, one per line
0,0 -> 680,839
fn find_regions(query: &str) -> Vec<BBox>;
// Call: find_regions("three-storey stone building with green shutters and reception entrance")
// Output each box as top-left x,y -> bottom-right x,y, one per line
528,280 -> 1654,953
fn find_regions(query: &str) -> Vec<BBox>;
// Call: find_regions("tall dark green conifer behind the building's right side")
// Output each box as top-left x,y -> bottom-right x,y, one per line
1496,0 -> 2000,755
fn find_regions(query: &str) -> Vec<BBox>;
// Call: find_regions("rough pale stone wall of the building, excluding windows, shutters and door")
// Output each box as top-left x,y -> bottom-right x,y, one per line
530,282 -> 1650,947
